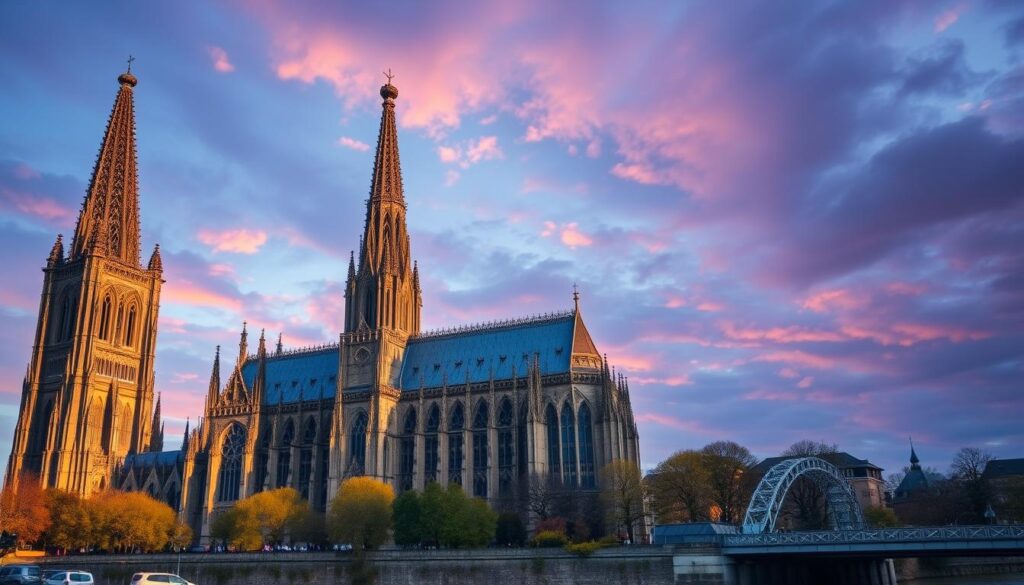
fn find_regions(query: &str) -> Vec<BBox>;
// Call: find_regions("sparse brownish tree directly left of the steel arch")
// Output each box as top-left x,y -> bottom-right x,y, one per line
700,441 -> 758,524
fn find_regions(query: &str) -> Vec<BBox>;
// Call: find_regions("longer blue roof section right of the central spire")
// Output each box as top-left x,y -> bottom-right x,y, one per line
400,311 -> 577,389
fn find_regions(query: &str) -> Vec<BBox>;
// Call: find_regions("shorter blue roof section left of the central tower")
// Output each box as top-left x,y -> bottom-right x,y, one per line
242,345 -> 338,405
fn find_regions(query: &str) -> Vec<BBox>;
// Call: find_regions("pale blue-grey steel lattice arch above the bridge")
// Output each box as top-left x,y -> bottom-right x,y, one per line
743,457 -> 864,534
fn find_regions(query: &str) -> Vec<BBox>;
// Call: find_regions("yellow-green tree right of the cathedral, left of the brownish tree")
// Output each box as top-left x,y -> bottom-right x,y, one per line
647,450 -> 711,524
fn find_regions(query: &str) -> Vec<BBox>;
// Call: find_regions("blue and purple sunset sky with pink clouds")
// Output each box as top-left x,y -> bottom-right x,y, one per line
0,0 -> 1024,472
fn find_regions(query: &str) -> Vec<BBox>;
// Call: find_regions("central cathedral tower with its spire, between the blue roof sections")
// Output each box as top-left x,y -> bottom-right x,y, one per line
330,75 -> 423,491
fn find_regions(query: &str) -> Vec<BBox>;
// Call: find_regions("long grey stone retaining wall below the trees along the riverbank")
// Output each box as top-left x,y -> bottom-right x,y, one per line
39,547 -> 675,585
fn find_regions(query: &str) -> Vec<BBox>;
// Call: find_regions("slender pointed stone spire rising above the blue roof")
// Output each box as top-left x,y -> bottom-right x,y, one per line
345,74 -> 422,334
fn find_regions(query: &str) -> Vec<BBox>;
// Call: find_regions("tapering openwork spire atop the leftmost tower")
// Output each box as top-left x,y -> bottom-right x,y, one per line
72,64 -> 140,265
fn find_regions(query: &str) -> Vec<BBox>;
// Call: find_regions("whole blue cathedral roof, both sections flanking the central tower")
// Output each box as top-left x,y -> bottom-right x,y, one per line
242,311 -> 596,405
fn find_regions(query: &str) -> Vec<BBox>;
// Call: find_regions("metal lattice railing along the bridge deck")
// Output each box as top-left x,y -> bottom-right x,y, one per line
722,525 -> 1024,547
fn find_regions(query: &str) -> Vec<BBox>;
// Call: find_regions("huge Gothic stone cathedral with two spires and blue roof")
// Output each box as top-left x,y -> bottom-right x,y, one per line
6,66 -> 639,543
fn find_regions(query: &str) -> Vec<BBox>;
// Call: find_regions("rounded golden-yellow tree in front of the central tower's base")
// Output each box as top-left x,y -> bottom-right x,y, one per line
328,477 -> 394,554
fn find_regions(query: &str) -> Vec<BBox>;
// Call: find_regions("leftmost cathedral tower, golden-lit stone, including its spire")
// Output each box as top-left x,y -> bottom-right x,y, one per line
6,64 -> 163,496
